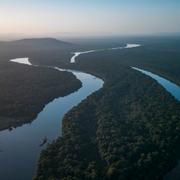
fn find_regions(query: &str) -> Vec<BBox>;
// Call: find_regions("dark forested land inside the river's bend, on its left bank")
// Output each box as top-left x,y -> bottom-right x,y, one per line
0,59 -> 81,130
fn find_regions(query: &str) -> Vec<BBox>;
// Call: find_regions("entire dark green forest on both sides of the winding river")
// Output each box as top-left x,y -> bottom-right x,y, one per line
0,37 -> 180,180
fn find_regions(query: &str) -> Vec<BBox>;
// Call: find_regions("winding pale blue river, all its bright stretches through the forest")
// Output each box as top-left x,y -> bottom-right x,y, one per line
0,44 -> 180,180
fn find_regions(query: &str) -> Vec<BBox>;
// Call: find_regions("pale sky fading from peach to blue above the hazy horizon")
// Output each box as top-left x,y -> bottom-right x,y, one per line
0,0 -> 180,36
